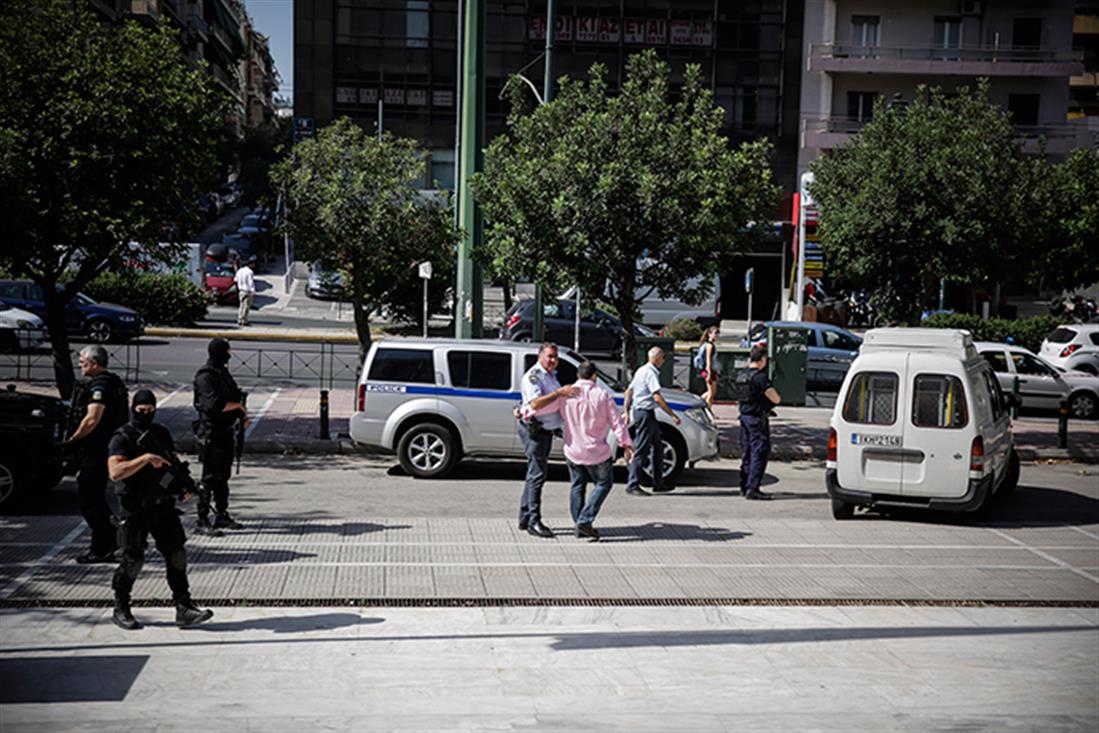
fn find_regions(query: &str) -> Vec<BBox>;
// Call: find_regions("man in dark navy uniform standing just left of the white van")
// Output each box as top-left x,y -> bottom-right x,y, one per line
736,346 -> 782,500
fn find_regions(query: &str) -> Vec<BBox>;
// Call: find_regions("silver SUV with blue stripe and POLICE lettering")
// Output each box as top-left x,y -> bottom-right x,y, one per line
351,338 -> 718,478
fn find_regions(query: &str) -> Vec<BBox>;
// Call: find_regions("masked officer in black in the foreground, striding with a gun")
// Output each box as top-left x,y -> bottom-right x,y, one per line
107,389 -> 213,631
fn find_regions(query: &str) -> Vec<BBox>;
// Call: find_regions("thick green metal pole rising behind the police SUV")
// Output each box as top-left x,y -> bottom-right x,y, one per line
454,0 -> 485,338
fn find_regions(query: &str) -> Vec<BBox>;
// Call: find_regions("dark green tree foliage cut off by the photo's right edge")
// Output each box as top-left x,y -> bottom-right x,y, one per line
1030,147 -> 1099,290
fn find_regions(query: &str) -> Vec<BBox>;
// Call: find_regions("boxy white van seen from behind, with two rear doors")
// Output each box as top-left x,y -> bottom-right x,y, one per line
825,329 -> 1019,519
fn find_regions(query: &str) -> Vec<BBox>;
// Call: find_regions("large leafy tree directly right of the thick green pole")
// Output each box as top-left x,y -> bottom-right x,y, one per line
473,51 -> 778,366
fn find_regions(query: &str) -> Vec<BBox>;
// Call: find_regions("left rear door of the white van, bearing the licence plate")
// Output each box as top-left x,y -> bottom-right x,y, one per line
835,359 -> 904,496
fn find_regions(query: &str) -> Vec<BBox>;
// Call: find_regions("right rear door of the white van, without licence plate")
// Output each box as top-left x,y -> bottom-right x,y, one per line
901,367 -> 975,499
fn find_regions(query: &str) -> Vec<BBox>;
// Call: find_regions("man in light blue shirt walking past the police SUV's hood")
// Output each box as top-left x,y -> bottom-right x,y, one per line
622,346 -> 681,497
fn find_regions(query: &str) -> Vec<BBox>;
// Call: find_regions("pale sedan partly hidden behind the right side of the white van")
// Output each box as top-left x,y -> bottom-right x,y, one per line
974,341 -> 1099,420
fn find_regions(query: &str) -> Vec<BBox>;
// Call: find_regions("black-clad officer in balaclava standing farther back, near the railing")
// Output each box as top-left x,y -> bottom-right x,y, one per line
195,338 -> 247,534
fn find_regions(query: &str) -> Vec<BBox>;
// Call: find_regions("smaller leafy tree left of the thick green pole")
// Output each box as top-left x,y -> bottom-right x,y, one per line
271,118 -> 458,355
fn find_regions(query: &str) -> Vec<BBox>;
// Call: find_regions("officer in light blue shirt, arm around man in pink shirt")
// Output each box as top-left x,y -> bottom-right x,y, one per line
519,343 -> 578,537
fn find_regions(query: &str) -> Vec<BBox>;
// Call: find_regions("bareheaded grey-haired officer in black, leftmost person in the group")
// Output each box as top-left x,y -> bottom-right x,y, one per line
66,344 -> 129,565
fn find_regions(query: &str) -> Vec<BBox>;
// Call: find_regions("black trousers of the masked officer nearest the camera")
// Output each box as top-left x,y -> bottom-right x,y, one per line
111,501 -> 190,602
